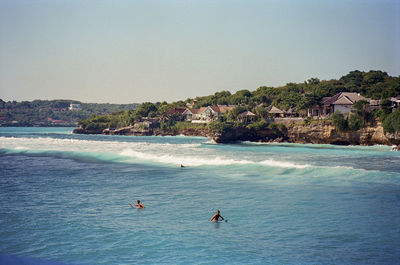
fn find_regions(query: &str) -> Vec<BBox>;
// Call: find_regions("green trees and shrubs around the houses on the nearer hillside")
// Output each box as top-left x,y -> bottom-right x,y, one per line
79,70 -> 400,132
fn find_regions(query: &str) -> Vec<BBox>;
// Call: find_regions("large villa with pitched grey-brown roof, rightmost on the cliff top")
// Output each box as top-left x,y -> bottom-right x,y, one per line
308,92 -> 380,117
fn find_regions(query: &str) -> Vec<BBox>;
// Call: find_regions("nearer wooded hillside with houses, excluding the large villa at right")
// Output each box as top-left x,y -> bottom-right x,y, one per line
73,70 -> 400,141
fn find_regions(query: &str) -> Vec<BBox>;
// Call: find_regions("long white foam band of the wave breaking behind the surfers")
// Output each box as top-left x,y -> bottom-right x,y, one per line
0,137 -> 309,169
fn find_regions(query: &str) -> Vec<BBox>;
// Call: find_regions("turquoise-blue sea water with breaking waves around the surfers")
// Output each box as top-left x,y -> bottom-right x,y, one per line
0,128 -> 400,264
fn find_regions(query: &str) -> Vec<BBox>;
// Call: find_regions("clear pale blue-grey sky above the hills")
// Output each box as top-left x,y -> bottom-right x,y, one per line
0,0 -> 400,104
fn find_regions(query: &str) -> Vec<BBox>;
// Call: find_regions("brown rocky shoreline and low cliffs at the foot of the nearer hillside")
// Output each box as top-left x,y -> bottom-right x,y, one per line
73,123 -> 400,149
